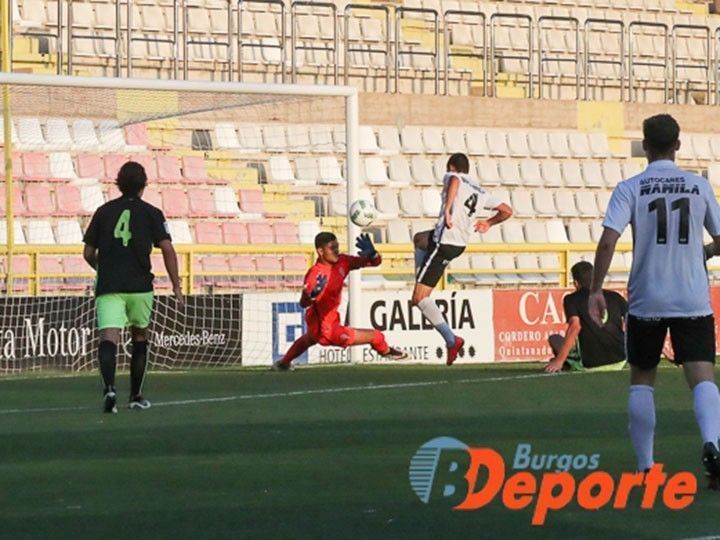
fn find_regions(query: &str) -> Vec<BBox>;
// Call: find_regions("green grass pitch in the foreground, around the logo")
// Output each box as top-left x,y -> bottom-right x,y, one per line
0,365 -> 720,540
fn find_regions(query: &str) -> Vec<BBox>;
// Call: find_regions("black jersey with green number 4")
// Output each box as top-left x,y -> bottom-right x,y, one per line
83,196 -> 170,296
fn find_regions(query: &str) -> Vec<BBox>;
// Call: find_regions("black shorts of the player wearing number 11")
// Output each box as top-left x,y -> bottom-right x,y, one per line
626,315 -> 715,369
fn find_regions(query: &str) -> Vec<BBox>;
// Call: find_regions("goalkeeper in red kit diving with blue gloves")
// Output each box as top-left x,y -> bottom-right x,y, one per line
273,232 -> 407,370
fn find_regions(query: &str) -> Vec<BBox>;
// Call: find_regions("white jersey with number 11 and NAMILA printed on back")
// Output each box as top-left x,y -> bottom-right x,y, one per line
603,160 -> 720,318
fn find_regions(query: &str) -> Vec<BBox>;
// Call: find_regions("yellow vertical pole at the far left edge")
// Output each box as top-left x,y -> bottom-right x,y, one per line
0,0 -> 15,295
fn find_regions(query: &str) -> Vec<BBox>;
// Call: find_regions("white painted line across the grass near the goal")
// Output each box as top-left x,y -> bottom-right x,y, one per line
0,372 -> 586,415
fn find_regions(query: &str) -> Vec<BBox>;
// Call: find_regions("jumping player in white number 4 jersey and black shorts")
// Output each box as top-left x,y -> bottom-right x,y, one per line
412,154 -> 512,366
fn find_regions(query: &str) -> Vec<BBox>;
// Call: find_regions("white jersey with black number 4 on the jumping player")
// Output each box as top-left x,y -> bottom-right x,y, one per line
433,172 -> 502,247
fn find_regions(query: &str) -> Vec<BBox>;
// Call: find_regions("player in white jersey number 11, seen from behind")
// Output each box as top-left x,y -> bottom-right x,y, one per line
589,114 -> 720,487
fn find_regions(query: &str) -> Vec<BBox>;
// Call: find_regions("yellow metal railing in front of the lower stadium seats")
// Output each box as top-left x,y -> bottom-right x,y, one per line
0,244 -> 631,295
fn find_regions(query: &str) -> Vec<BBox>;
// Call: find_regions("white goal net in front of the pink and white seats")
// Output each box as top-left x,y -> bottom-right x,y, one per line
0,74 -> 359,373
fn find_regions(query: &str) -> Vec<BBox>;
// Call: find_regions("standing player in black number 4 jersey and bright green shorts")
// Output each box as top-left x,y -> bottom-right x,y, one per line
83,161 -> 183,413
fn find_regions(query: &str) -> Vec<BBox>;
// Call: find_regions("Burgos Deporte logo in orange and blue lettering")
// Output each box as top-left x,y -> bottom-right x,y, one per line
409,437 -> 697,525
